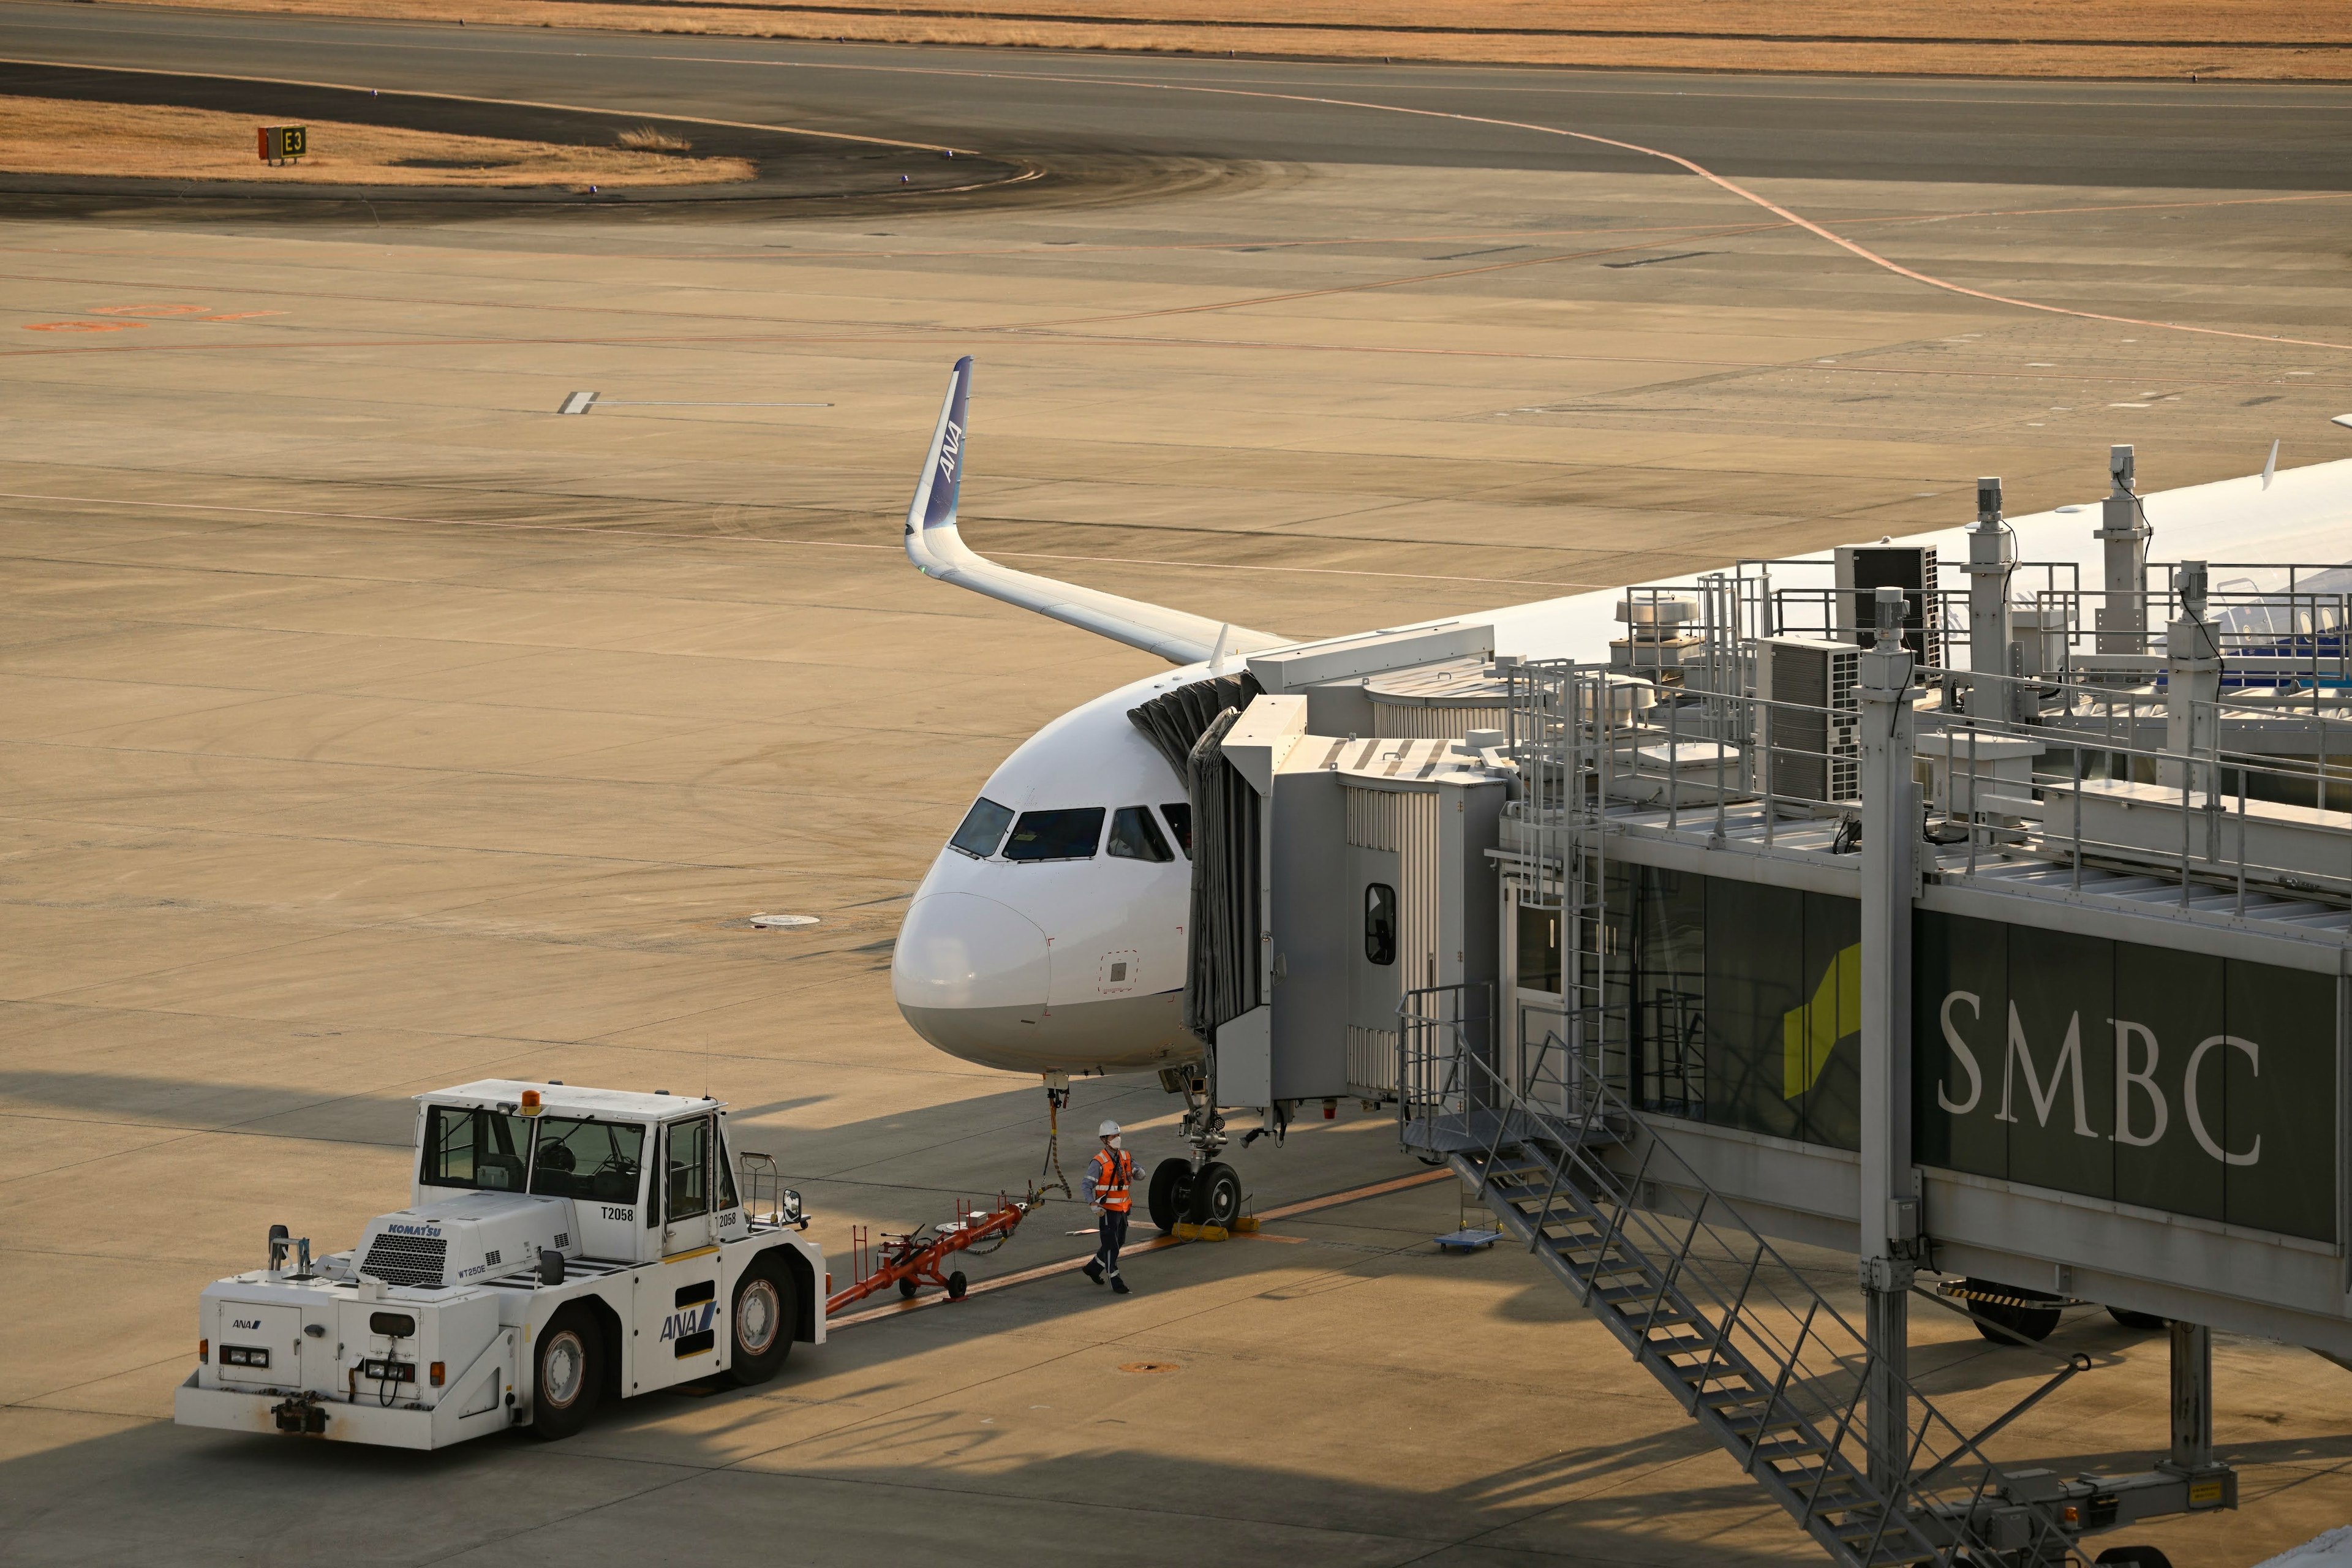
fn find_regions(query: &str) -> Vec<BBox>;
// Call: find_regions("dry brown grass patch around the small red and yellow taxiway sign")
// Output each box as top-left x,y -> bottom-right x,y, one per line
0,96 -> 753,186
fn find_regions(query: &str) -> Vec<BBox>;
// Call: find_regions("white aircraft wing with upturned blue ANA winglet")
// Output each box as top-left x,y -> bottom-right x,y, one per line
905,355 -> 1296,665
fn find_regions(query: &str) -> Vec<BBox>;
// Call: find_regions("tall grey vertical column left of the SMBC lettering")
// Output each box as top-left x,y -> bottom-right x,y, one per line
1858,588 -> 1919,1495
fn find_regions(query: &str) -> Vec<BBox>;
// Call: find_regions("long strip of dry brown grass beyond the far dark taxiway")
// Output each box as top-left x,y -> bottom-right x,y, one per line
74,0 -> 2352,80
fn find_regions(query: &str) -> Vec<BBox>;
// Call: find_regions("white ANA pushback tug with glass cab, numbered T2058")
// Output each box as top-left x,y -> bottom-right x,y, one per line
174,1079 -> 826,1448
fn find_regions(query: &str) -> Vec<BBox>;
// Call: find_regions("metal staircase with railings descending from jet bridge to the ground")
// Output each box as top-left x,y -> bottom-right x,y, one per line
1400,1006 -> 2079,1568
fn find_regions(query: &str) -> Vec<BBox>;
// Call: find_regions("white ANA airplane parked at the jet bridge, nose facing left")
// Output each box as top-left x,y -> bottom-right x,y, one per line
891,355 -> 2352,1222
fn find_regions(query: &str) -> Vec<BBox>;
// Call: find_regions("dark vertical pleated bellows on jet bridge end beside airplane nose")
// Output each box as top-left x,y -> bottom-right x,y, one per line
1169,710 -> 1263,1044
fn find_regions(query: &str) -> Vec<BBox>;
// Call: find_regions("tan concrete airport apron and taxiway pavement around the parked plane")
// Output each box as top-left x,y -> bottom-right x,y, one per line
13,15 -> 2352,1568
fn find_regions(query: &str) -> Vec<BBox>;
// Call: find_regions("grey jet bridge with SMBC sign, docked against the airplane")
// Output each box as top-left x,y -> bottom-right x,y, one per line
1166,449 -> 2352,1566
